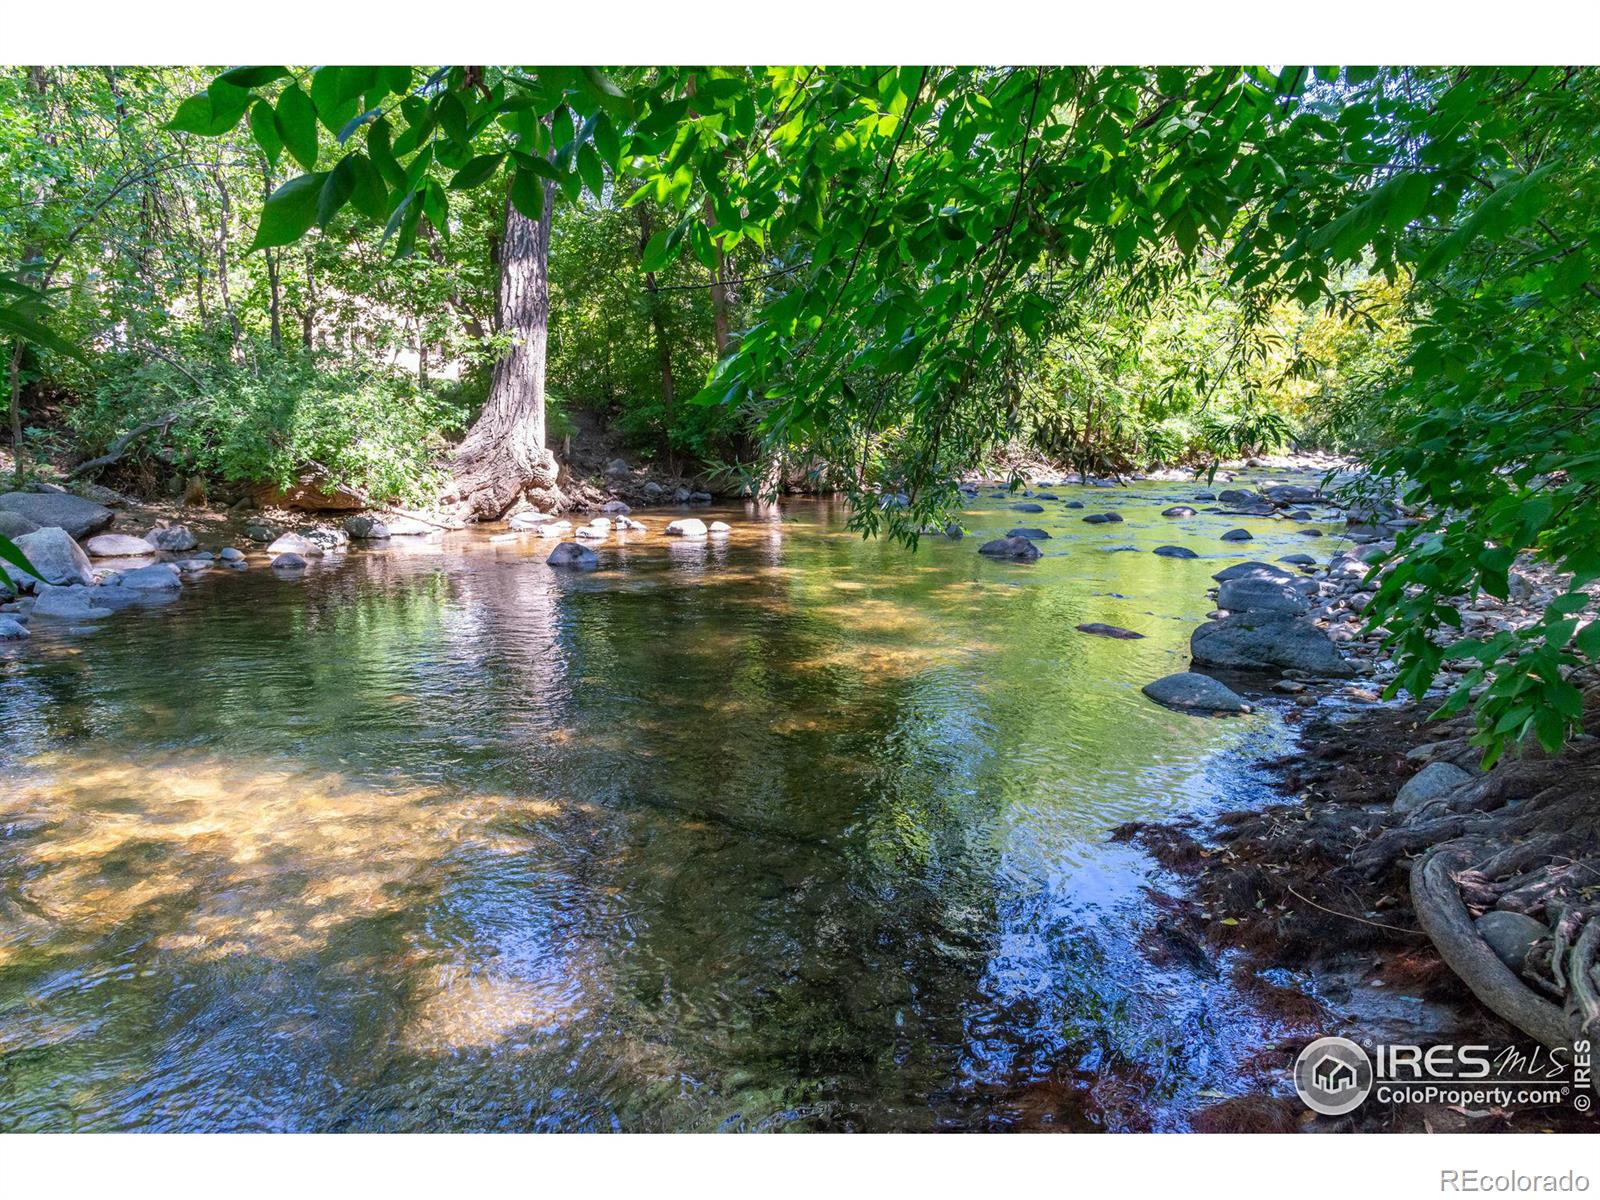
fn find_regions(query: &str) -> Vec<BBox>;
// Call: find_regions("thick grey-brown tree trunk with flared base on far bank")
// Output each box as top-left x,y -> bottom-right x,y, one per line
450,184 -> 560,520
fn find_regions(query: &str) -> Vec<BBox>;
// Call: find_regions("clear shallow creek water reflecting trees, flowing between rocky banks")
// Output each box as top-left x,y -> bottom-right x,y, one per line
0,483 -> 1331,1131
